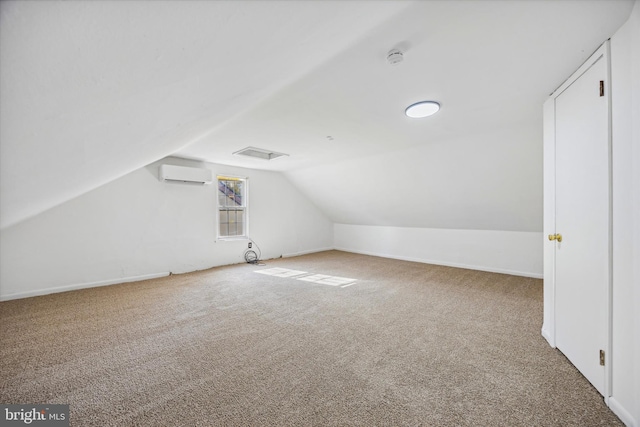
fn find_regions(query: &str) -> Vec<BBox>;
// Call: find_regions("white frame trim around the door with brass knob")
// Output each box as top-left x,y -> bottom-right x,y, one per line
542,40 -> 613,404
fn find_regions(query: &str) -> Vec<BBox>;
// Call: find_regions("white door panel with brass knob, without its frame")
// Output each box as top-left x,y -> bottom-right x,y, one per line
554,56 -> 609,395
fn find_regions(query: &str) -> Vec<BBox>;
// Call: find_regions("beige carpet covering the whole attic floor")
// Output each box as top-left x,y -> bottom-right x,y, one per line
0,251 -> 622,427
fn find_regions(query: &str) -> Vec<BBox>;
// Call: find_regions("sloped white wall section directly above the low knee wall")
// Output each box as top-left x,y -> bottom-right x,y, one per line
285,122 -> 542,232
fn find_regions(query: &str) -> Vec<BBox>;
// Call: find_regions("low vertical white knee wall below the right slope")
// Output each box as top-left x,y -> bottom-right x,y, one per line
334,224 -> 542,278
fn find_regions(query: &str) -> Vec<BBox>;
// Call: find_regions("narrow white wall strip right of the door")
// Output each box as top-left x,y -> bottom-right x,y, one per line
610,1 -> 640,426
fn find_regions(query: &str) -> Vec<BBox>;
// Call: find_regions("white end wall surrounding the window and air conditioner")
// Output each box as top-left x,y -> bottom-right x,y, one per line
0,158 -> 333,299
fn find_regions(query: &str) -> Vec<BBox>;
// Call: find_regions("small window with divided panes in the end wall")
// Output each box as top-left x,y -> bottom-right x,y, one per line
218,176 -> 247,237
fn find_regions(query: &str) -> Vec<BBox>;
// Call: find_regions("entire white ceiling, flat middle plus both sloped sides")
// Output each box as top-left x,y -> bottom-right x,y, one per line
0,0 -> 633,231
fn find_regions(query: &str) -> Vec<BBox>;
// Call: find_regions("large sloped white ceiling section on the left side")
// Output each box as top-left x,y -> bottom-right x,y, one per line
0,0 -> 408,227
